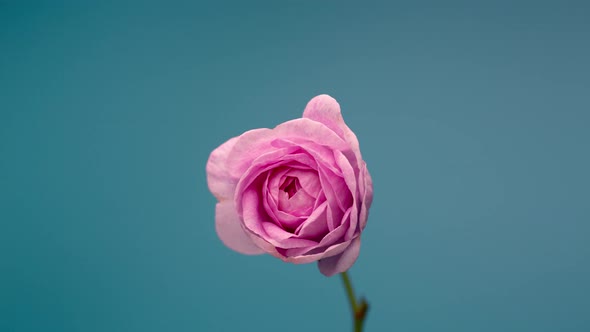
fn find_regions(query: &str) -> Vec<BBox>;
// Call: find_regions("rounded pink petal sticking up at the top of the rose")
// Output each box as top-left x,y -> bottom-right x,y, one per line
303,95 -> 361,160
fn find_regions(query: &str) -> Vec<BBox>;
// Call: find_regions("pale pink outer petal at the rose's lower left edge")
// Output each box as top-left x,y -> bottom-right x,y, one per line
215,200 -> 264,255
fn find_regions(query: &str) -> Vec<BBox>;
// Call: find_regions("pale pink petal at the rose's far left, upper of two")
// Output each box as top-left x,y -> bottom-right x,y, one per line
206,137 -> 238,201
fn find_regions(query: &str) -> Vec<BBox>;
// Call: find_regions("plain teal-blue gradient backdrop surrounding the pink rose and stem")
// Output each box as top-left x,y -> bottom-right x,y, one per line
0,1 -> 590,332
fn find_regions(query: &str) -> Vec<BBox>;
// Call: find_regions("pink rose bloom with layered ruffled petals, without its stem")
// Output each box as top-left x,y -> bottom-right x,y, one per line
207,95 -> 373,276
